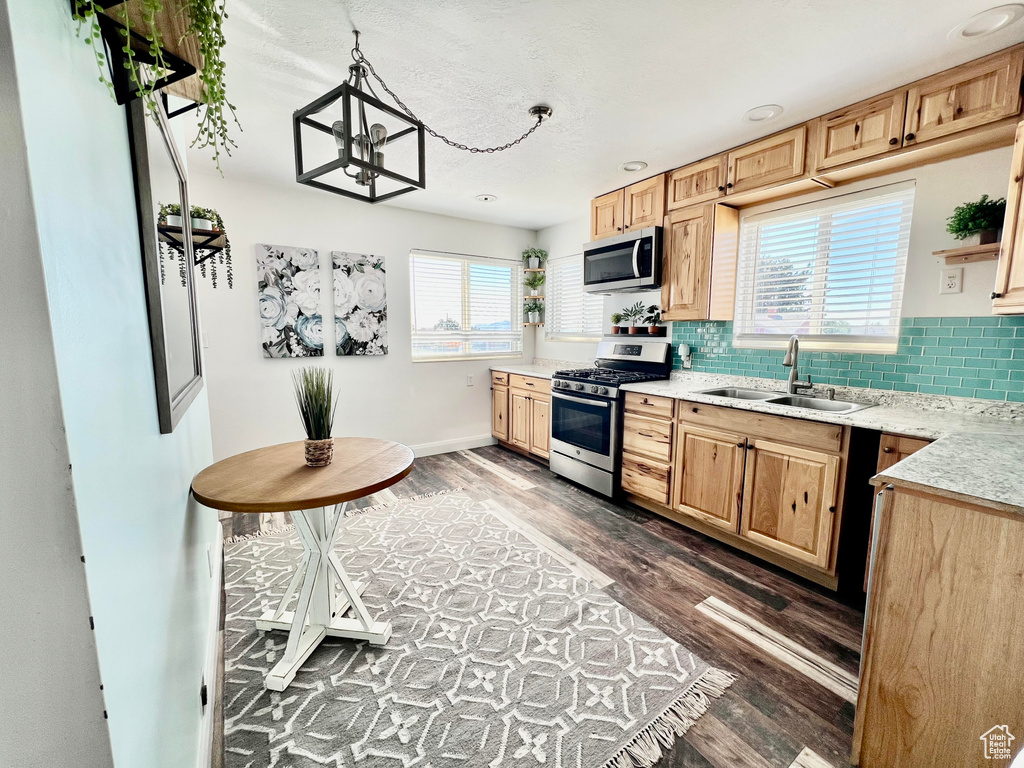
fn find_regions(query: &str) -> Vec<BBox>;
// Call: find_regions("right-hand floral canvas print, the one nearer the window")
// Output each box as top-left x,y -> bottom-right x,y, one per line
331,251 -> 387,354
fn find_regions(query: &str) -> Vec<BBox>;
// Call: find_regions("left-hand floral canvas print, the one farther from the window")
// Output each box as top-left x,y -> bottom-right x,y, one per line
256,244 -> 324,357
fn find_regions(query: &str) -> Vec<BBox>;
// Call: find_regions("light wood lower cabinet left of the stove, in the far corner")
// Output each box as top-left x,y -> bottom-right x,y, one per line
490,372 -> 551,459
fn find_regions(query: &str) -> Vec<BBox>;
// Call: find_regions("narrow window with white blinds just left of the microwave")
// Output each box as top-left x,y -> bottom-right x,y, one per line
543,253 -> 604,340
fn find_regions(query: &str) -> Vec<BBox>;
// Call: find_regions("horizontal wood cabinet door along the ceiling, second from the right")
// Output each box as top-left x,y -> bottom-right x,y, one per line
816,89 -> 906,170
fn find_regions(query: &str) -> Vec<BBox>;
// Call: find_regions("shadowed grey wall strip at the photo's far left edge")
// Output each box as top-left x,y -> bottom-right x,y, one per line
0,2 -> 112,768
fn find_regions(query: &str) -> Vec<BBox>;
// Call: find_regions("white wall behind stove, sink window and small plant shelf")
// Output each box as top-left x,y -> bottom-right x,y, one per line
536,146 -> 1013,360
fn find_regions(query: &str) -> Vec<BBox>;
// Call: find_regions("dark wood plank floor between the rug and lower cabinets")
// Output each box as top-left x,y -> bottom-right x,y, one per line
225,446 -> 863,768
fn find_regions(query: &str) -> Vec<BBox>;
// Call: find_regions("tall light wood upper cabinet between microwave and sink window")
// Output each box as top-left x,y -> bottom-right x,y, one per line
662,203 -> 739,321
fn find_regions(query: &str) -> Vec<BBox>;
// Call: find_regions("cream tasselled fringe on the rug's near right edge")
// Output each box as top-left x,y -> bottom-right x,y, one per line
604,667 -> 736,768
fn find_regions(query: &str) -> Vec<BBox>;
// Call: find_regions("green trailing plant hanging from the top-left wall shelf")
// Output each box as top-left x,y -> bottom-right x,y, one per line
75,0 -> 242,173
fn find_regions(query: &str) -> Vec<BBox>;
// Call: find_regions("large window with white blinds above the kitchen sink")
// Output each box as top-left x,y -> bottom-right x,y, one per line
733,181 -> 914,351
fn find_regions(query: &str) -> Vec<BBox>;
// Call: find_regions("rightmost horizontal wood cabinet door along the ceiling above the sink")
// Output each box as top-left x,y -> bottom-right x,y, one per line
903,46 -> 1024,144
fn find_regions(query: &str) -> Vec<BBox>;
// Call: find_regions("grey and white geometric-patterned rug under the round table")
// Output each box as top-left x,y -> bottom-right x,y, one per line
224,492 -> 732,768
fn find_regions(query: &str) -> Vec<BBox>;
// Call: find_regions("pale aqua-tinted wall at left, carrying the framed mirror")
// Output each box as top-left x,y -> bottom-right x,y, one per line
4,0 -> 219,768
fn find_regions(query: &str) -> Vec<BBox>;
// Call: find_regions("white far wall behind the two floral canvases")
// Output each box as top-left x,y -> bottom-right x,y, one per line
190,174 -> 536,459
